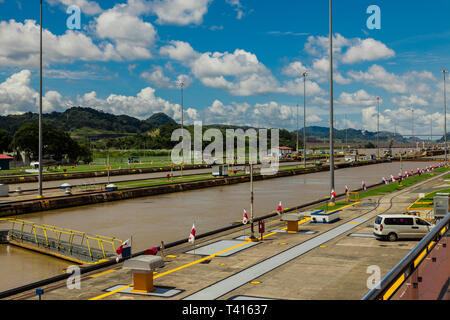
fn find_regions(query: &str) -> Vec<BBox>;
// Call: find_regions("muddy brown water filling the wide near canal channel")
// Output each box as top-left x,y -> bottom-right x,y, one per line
0,162 -> 438,291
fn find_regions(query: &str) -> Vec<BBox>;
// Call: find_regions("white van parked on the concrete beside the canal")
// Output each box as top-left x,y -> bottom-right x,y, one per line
373,214 -> 434,241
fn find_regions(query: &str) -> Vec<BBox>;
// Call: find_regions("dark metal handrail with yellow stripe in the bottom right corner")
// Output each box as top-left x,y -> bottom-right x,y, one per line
361,214 -> 450,300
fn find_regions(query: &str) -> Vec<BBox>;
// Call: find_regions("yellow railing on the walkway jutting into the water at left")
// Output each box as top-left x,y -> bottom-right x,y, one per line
0,218 -> 122,259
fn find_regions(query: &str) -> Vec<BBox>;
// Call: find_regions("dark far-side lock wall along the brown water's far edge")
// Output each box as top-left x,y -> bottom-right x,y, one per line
0,160 -> 389,217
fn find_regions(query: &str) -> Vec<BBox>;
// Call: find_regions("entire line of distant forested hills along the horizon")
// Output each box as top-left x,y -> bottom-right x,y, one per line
0,107 -> 436,144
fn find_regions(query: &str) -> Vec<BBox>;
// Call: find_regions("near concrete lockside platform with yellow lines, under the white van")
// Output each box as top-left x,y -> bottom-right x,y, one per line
4,171 -> 450,300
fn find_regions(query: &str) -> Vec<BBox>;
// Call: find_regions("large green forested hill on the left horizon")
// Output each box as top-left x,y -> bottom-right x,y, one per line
0,107 -> 176,137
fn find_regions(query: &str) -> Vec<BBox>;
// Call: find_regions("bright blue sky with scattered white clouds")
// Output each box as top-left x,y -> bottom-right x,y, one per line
0,0 -> 450,135
